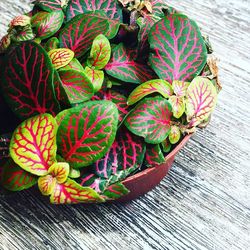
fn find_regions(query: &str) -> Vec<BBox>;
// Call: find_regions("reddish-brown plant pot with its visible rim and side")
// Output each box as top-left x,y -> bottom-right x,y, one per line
115,135 -> 191,202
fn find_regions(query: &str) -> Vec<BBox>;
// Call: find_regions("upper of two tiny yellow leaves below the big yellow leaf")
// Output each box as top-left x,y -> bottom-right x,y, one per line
48,162 -> 70,184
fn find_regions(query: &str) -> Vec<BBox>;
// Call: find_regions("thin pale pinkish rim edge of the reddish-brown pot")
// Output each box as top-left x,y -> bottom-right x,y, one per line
122,134 -> 192,186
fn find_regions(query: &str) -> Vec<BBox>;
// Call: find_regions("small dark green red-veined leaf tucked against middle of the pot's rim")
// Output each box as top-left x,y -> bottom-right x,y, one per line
144,144 -> 166,167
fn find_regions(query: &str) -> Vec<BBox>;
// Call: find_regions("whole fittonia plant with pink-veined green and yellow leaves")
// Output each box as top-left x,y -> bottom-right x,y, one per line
0,0 -> 220,204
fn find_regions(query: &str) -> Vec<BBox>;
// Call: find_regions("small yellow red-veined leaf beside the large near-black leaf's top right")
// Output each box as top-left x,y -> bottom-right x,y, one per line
48,49 -> 75,69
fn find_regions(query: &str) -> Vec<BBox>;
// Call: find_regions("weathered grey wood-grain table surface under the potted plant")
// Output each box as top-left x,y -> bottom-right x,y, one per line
0,0 -> 250,250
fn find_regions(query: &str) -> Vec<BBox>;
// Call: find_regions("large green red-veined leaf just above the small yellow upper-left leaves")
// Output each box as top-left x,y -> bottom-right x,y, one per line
59,14 -> 109,58
